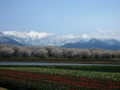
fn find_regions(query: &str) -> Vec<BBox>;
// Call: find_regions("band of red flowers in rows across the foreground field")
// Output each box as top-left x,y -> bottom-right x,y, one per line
0,69 -> 120,90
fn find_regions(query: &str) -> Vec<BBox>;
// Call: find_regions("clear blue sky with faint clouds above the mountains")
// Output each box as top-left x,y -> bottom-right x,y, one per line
0,0 -> 120,39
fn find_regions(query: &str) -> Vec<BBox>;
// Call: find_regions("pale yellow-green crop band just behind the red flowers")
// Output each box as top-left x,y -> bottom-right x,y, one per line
0,66 -> 120,80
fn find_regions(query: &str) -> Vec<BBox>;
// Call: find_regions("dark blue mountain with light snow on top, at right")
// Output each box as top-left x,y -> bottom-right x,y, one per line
61,38 -> 120,50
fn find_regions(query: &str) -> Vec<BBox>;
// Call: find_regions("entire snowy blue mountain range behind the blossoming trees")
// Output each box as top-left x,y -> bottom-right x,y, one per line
0,30 -> 120,50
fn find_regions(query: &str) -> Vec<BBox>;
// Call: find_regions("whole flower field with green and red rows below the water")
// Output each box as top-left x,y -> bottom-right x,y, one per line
0,65 -> 120,90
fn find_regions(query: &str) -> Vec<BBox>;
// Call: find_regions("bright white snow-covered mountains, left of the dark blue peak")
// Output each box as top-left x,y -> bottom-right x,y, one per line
2,31 -> 81,46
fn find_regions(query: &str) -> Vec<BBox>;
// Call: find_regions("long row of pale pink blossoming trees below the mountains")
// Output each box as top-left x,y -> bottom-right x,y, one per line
0,44 -> 120,58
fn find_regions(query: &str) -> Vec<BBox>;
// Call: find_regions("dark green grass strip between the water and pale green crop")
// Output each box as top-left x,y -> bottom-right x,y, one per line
0,65 -> 120,73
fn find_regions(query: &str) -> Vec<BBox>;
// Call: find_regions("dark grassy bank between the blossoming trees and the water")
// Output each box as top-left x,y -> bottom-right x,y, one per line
0,57 -> 120,64
